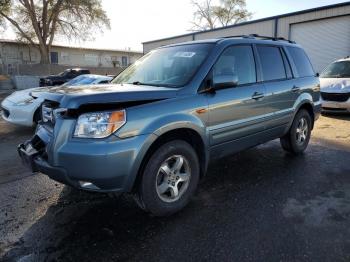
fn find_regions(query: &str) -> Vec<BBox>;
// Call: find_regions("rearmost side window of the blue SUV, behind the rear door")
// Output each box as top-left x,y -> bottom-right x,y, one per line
287,47 -> 315,77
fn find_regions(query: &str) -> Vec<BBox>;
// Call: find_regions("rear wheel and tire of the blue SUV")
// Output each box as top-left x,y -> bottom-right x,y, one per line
280,109 -> 312,155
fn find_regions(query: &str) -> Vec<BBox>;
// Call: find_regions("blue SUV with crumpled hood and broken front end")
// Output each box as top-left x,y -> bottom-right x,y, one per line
18,35 -> 321,216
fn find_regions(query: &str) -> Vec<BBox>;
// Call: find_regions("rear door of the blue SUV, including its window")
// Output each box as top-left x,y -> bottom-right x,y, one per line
256,45 -> 299,129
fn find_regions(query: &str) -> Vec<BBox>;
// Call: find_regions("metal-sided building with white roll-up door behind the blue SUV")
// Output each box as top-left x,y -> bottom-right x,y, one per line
143,2 -> 350,72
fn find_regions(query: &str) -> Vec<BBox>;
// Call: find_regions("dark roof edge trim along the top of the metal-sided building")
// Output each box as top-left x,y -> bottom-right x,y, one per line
142,1 -> 350,44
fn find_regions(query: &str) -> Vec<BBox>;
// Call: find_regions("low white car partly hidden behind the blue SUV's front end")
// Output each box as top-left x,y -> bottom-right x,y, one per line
1,74 -> 112,126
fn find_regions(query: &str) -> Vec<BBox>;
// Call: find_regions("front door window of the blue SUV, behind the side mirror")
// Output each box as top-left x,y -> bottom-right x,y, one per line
213,46 -> 256,85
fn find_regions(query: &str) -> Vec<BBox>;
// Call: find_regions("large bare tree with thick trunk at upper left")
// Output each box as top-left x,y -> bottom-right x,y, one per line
0,0 -> 110,64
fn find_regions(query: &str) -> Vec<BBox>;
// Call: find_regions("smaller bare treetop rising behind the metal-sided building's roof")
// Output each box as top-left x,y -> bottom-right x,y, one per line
192,0 -> 252,31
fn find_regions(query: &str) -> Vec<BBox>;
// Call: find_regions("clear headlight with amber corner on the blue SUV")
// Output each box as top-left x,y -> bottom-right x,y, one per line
74,110 -> 126,138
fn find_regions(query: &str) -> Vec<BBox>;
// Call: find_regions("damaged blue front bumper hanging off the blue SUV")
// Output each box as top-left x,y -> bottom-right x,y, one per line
18,120 -> 156,193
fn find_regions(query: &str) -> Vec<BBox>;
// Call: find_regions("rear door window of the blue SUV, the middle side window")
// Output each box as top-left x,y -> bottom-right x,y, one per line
257,46 -> 286,81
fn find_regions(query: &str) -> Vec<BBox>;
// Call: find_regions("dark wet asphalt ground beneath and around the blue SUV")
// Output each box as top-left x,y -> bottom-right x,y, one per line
0,109 -> 350,261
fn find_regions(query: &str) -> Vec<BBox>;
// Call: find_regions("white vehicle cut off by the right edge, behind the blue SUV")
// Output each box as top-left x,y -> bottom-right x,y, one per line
320,56 -> 350,112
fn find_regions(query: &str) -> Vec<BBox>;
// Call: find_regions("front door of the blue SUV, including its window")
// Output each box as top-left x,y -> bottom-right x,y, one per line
208,45 -> 266,157
